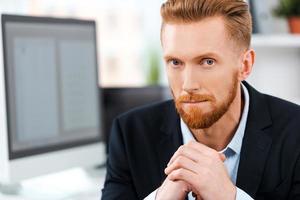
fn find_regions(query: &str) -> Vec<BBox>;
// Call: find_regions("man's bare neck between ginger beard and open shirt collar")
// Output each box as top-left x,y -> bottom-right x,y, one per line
191,86 -> 245,151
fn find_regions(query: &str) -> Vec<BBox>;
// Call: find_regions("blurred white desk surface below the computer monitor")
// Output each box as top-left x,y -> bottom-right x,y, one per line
0,168 -> 105,200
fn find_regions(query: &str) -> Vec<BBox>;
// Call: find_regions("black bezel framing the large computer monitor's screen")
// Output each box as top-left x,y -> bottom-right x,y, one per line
1,14 -> 104,160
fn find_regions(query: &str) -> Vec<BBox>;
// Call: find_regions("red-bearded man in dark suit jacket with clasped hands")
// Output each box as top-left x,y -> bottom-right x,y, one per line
102,0 -> 300,200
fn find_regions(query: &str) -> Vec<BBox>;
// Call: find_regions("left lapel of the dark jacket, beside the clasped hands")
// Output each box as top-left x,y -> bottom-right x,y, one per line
156,101 -> 183,181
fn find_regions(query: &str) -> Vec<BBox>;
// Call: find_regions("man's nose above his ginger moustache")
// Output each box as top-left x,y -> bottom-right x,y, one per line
182,66 -> 200,93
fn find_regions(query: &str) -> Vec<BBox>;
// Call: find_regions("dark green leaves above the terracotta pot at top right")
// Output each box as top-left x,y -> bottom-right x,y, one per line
274,0 -> 300,17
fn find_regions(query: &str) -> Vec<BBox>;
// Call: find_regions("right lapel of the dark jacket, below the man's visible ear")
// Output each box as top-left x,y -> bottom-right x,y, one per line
237,82 -> 272,198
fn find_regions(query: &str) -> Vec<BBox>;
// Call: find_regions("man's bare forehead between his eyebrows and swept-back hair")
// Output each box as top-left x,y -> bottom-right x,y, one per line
162,17 -> 240,57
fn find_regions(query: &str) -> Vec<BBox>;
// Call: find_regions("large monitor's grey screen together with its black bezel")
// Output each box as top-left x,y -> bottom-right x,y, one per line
2,15 -> 102,159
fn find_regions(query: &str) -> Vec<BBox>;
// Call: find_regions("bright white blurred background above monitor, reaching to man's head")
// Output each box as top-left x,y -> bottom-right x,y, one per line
0,0 -> 163,87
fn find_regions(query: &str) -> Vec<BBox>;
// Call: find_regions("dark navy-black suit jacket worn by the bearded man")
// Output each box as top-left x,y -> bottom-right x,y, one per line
102,82 -> 300,200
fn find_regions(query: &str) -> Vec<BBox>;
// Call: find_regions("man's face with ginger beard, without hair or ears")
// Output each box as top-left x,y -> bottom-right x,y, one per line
162,17 -> 241,129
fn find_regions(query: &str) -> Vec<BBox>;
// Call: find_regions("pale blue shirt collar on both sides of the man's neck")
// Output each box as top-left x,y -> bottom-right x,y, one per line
180,83 -> 250,154
